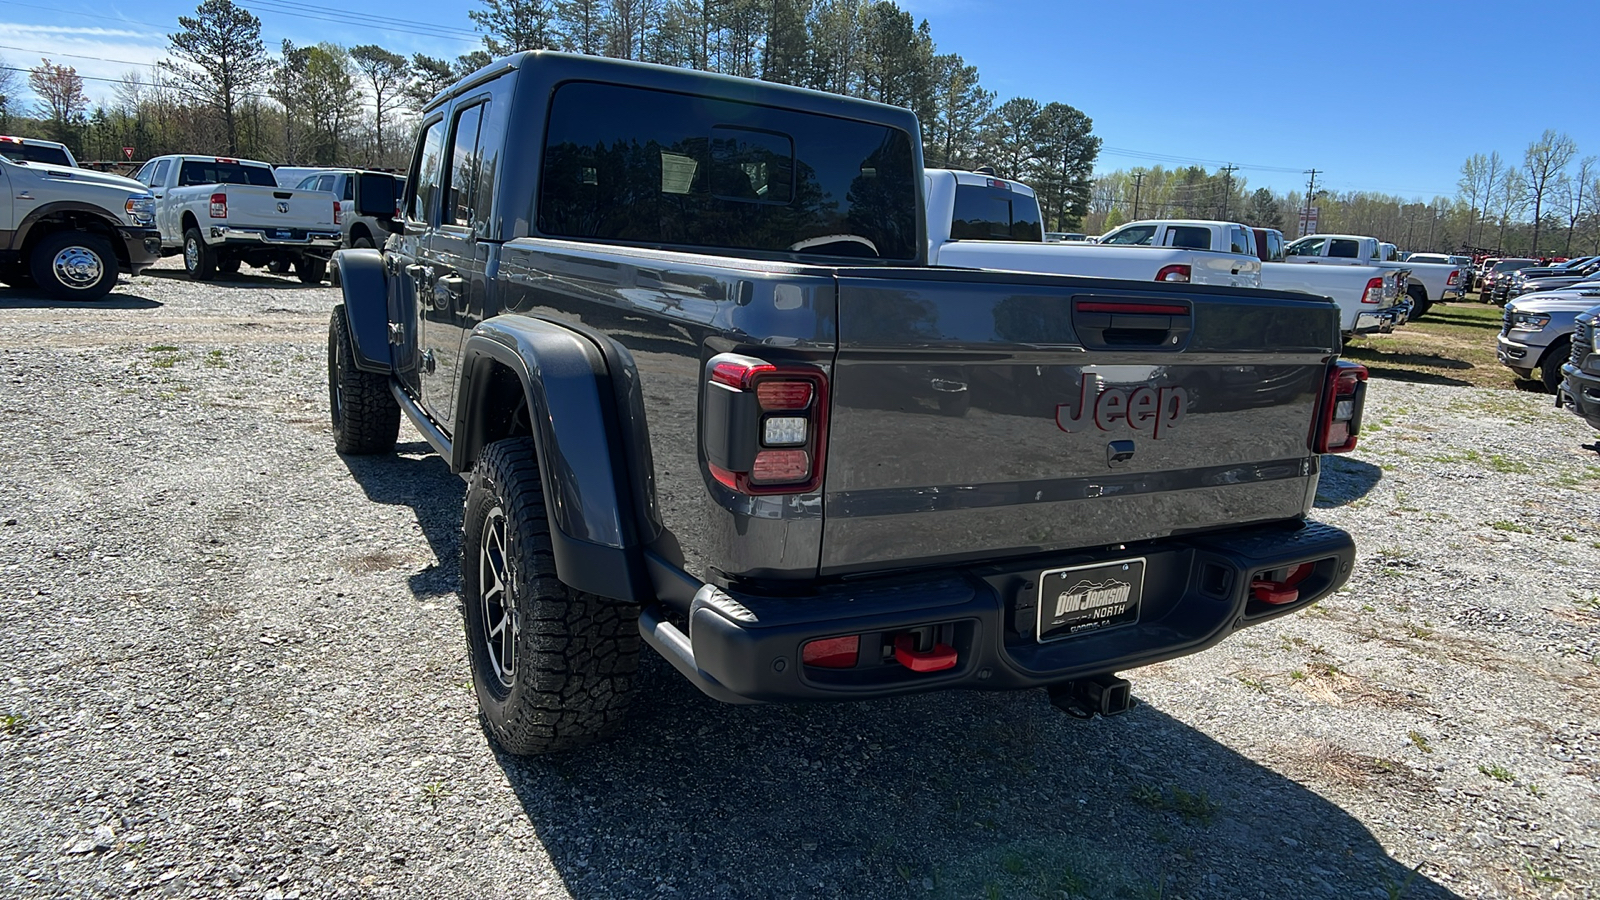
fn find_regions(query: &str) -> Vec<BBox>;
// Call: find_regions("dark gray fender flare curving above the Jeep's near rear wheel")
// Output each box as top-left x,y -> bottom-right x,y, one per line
450,315 -> 651,602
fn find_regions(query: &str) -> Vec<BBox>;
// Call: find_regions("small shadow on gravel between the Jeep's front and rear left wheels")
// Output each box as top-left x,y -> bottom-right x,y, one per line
341,440 -> 467,597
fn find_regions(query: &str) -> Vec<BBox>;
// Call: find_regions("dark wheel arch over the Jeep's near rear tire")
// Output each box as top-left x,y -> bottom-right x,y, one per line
450,315 -> 661,602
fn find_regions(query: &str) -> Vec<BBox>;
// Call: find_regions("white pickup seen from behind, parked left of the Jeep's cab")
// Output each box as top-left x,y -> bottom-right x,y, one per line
134,155 -> 342,283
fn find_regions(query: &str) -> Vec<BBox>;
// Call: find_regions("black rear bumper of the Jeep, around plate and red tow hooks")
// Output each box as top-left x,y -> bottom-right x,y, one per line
640,522 -> 1355,703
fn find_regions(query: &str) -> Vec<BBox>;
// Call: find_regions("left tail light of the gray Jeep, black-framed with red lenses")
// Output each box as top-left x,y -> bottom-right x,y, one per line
701,354 -> 827,495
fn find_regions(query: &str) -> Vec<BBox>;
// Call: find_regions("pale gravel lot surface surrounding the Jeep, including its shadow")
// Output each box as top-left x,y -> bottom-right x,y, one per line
0,261 -> 1600,898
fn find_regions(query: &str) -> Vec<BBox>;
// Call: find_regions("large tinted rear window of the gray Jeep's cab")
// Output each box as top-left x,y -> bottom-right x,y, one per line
538,82 -> 917,259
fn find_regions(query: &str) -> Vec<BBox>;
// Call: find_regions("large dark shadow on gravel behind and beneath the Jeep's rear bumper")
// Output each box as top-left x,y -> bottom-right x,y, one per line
499,672 -> 1456,900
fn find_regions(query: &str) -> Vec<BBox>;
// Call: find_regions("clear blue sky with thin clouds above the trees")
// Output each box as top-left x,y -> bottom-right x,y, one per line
0,0 -> 1600,199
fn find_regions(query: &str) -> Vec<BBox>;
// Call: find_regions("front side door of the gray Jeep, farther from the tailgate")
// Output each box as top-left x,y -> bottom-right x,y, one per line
393,117 -> 445,397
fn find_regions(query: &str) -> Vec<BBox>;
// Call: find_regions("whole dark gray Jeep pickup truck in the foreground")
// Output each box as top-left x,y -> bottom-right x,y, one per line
328,51 -> 1366,754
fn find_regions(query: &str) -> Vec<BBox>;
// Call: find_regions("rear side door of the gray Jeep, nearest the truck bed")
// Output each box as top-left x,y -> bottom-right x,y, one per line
418,99 -> 488,429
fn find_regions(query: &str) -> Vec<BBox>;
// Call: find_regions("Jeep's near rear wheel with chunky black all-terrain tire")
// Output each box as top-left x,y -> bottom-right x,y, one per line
461,437 -> 640,756
